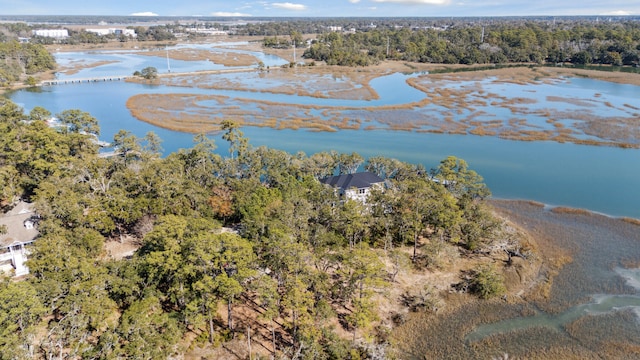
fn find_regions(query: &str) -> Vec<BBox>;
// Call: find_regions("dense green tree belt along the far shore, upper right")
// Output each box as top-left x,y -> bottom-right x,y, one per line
304,22 -> 640,66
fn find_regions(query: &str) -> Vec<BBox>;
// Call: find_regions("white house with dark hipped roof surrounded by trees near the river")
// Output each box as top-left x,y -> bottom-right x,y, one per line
320,172 -> 384,204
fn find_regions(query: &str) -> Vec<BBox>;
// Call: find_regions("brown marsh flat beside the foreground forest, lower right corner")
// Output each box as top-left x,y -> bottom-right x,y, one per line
393,200 -> 640,359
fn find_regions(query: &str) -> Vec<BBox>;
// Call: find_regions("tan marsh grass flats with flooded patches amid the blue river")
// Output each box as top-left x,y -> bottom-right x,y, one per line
127,67 -> 640,148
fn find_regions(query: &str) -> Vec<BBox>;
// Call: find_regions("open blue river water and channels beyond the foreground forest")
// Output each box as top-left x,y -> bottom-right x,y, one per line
7,47 -> 640,218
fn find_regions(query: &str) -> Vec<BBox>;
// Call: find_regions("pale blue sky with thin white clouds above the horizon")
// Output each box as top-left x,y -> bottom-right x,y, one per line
0,0 -> 640,17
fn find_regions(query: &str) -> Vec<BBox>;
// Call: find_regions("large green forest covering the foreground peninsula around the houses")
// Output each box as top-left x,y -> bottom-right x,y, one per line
0,100 -> 534,359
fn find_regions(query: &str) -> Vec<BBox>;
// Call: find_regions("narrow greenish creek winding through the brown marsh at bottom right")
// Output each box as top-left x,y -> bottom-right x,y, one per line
466,268 -> 640,342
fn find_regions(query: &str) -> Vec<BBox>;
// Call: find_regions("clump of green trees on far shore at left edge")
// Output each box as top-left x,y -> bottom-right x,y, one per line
0,40 -> 56,86
